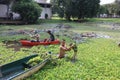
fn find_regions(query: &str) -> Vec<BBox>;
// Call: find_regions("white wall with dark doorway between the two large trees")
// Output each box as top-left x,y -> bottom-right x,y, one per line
40,8 -> 52,19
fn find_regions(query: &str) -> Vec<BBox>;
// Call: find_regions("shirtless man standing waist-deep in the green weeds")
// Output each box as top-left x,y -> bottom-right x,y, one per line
58,39 -> 73,58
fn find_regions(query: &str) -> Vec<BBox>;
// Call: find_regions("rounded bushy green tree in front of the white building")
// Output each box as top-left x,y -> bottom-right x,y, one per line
12,0 -> 41,23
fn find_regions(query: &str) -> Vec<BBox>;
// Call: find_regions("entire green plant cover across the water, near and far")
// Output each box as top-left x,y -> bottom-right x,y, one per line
0,18 -> 120,80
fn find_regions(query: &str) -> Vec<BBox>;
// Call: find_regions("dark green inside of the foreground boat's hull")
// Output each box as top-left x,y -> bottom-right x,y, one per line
0,54 -> 38,80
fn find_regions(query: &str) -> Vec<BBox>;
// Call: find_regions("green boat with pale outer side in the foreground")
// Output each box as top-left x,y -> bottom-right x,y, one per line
0,54 -> 49,80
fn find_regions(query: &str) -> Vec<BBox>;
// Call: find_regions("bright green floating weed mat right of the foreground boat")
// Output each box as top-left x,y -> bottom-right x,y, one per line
26,39 -> 120,80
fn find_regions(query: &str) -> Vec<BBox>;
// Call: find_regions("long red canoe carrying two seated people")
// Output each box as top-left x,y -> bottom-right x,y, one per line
19,39 -> 60,46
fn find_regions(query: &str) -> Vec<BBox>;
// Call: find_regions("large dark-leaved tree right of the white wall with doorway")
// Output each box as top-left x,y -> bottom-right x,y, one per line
51,0 -> 100,20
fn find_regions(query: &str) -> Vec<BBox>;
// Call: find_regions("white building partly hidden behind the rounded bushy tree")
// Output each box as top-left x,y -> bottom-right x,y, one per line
0,0 -> 52,20
